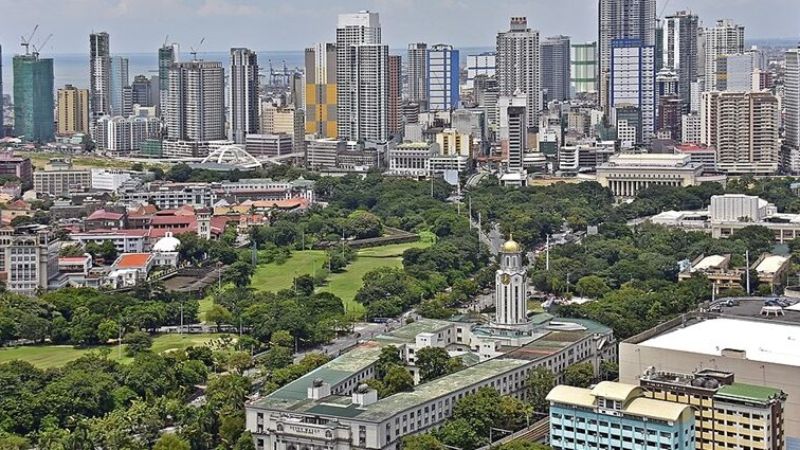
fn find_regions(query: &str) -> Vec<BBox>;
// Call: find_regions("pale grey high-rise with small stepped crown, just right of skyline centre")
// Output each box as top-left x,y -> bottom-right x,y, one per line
497,17 -> 542,128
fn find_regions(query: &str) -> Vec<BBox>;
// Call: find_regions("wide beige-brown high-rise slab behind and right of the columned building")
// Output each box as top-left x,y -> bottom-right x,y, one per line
700,91 -> 780,175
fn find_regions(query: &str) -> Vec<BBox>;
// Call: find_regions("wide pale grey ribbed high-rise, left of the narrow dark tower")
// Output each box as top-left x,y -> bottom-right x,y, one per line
164,61 -> 225,141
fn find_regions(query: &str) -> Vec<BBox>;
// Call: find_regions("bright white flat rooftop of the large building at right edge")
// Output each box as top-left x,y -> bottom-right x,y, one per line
639,318 -> 800,367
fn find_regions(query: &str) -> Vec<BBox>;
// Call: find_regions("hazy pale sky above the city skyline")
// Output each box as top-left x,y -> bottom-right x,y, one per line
0,0 -> 800,53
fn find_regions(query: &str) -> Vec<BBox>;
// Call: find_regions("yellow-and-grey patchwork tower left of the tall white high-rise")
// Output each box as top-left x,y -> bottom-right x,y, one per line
306,43 -> 337,138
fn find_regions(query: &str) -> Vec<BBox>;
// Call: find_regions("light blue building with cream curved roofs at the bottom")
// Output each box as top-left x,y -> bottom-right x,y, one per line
547,381 -> 695,450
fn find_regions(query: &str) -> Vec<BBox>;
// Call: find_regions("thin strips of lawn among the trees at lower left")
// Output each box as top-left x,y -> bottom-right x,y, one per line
0,334 -> 220,369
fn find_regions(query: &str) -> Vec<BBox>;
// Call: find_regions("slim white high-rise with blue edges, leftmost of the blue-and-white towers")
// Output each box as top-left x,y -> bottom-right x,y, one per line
425,44 -> 460,111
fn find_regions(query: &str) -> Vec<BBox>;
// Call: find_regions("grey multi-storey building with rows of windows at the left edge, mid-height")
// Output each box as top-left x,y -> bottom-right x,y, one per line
0,225 -> 61,295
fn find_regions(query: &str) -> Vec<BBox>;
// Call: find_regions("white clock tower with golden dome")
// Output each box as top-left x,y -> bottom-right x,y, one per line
495,237 -> 528,325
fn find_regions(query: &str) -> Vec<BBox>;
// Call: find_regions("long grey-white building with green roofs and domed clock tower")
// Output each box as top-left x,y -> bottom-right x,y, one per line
246,240 -> 616,450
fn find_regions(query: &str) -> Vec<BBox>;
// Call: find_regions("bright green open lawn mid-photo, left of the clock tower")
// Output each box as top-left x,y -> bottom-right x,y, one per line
250,240 -> 431,318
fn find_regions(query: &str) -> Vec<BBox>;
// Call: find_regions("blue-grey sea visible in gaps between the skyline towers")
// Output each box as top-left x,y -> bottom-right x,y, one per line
2,47 -> 492,100
